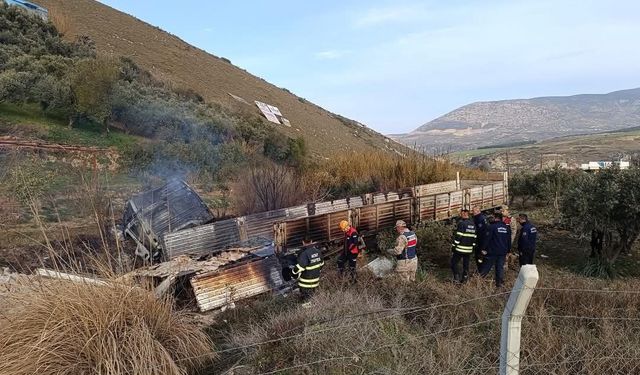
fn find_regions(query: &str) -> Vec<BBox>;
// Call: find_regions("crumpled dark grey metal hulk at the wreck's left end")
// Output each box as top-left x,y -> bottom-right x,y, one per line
122,179 -> 213,260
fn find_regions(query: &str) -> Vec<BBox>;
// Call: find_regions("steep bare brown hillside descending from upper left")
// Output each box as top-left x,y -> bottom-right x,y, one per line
33,0 -> 403,157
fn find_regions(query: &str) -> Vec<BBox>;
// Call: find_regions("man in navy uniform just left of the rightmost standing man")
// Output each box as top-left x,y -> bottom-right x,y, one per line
480,213 -> 511,288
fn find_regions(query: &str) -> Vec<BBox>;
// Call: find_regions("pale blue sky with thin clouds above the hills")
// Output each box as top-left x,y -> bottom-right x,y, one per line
102,0 -> 640,134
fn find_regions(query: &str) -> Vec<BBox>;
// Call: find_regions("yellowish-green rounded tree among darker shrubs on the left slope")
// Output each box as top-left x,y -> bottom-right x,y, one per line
69,59 -> 118,132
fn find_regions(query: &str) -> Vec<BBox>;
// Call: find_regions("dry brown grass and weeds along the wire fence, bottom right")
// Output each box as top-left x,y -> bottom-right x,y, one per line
210,268 -> 640,375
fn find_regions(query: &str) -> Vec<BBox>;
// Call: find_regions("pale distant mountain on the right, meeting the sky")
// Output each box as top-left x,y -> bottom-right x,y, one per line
393,88 -> 640,151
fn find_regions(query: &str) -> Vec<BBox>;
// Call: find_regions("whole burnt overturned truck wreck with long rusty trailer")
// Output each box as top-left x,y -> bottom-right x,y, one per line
125,173 -> 508,311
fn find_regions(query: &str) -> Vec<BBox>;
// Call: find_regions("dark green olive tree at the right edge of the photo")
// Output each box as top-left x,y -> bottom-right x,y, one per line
560,168 -> 640,266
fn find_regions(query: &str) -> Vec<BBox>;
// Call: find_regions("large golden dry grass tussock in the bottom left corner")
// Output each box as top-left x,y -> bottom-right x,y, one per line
0,281 -> 214,375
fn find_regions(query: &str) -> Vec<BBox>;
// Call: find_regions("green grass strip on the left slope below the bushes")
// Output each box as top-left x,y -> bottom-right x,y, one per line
0,103 -> 144,150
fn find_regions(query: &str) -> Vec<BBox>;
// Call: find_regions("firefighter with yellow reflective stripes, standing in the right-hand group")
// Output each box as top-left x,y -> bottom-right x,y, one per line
451,209 -> 477,283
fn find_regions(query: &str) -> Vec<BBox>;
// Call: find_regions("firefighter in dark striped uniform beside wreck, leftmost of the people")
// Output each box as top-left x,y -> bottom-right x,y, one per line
291,235 -> 324,302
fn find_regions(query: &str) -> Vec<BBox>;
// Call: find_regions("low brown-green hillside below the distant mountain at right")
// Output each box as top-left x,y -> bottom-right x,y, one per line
450,128 -> 640,170
